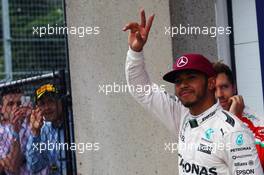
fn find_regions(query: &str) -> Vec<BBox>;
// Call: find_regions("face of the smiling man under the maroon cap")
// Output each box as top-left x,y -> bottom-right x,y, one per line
175,71 -> 207,107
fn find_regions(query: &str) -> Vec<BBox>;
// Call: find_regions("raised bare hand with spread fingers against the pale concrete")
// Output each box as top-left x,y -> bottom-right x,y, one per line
123,9 -> 154,52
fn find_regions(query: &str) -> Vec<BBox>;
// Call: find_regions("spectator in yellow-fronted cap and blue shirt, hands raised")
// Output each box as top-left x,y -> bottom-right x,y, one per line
27,84 -> 66,175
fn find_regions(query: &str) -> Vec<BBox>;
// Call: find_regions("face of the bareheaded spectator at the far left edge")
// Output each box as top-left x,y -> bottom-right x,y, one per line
1,93 -> 22,120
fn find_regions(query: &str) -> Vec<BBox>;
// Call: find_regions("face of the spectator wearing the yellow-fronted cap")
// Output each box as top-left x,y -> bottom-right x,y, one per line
37,96 -> 62,122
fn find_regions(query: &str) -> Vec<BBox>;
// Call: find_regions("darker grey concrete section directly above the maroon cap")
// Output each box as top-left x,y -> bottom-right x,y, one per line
170,0 -> 217,61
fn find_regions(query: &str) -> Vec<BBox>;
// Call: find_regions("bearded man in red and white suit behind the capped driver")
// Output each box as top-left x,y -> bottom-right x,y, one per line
214,62 -> 264,169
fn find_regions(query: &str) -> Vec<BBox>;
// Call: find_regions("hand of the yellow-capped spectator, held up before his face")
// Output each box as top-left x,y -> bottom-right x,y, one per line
30,107 -> 43,136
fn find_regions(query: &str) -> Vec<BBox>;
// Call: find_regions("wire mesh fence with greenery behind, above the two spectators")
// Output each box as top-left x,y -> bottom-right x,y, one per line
0,0 -> 67,80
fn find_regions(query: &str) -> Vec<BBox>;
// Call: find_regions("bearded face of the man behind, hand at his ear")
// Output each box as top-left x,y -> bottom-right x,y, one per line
215,73 -> 236,110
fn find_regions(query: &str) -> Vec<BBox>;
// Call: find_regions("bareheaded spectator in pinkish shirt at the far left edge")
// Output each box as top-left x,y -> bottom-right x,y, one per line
0,87 -> 31,175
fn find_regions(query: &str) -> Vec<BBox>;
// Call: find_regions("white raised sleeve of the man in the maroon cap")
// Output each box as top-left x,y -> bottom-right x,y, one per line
126,49 -> 183,133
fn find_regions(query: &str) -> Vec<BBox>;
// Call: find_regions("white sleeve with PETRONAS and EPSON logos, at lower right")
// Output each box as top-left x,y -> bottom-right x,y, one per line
223,130 -> 263,175
